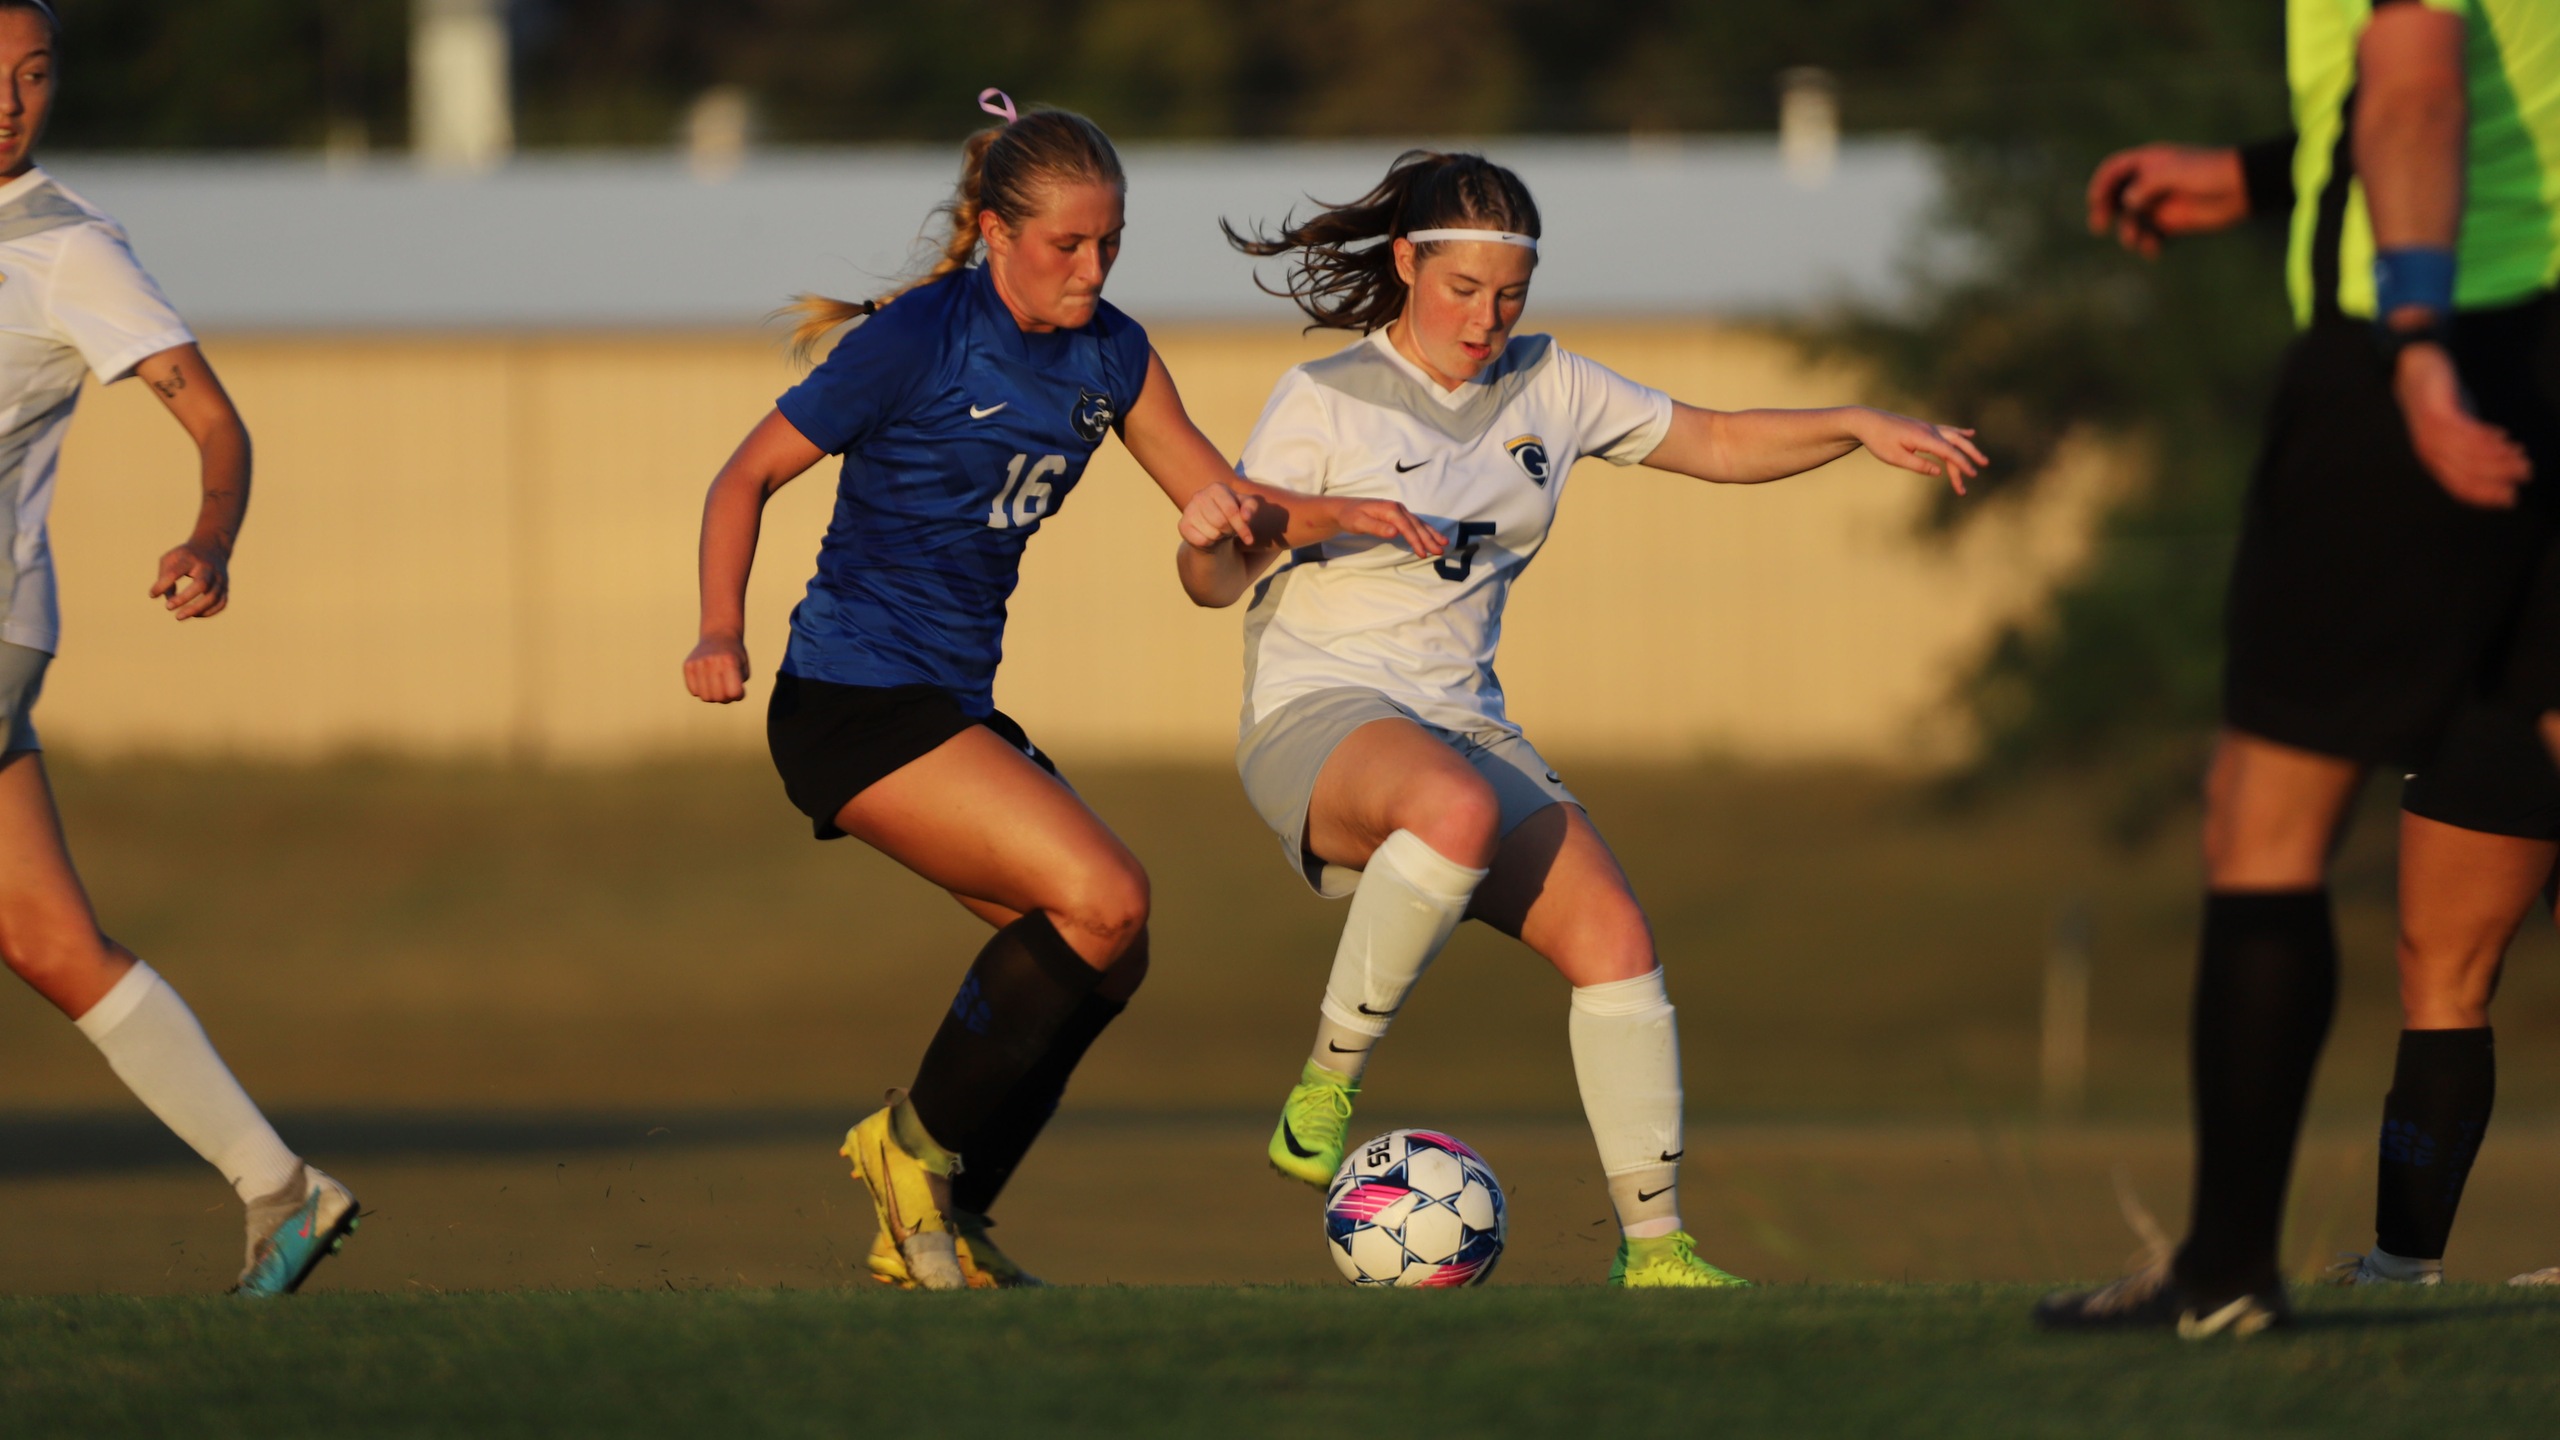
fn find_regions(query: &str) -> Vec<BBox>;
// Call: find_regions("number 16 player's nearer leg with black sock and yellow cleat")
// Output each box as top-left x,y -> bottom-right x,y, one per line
837,725 -> 1147,1289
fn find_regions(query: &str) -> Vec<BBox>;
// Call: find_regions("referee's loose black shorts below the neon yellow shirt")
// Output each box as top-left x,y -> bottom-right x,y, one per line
2222,297 -> 2560,764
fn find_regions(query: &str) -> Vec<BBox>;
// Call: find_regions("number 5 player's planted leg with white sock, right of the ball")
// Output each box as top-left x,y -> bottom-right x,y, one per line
1472,805 -> 1743,1289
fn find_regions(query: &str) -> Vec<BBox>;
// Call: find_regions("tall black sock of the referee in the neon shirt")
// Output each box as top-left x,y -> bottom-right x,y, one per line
2176,889 -> 2337,1299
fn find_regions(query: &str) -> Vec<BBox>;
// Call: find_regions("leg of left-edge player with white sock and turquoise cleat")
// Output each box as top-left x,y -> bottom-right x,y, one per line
0,751 -> 356,1297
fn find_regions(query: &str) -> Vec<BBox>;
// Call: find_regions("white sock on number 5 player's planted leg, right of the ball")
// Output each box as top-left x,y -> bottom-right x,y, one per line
1572,966 -> 1682,1240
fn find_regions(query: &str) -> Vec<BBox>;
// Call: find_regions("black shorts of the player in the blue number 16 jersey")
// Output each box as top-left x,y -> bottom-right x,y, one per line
765,674 -> 1057,840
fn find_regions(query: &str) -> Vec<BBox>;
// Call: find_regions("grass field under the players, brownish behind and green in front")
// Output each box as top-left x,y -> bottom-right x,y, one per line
15,756 -> 2560,1437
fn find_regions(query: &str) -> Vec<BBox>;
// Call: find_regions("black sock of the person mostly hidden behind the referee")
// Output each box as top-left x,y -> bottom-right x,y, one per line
2373,1025 -> 2499,1261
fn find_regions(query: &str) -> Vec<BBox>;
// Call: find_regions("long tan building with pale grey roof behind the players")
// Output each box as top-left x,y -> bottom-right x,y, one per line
46,131 -> 2109,766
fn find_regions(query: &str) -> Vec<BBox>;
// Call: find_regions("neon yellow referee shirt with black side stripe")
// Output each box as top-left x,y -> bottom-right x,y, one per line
2284,0 -> 2560,325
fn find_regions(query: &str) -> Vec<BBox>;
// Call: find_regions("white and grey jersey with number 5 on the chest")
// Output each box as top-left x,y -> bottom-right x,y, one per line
1239,331 -> 1672,730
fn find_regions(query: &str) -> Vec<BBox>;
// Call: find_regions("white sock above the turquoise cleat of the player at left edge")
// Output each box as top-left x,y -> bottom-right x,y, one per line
74,961 -> 302,1202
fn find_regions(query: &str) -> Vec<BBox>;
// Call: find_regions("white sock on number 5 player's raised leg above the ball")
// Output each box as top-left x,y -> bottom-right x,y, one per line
1308,830 -> 1485,1079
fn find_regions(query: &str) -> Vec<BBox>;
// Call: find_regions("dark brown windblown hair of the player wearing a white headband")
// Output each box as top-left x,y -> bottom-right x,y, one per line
1219,151 -> 1539,333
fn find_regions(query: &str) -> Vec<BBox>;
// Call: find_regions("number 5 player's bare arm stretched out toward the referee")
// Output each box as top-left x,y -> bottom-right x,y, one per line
1644,405 -> 1992,495
